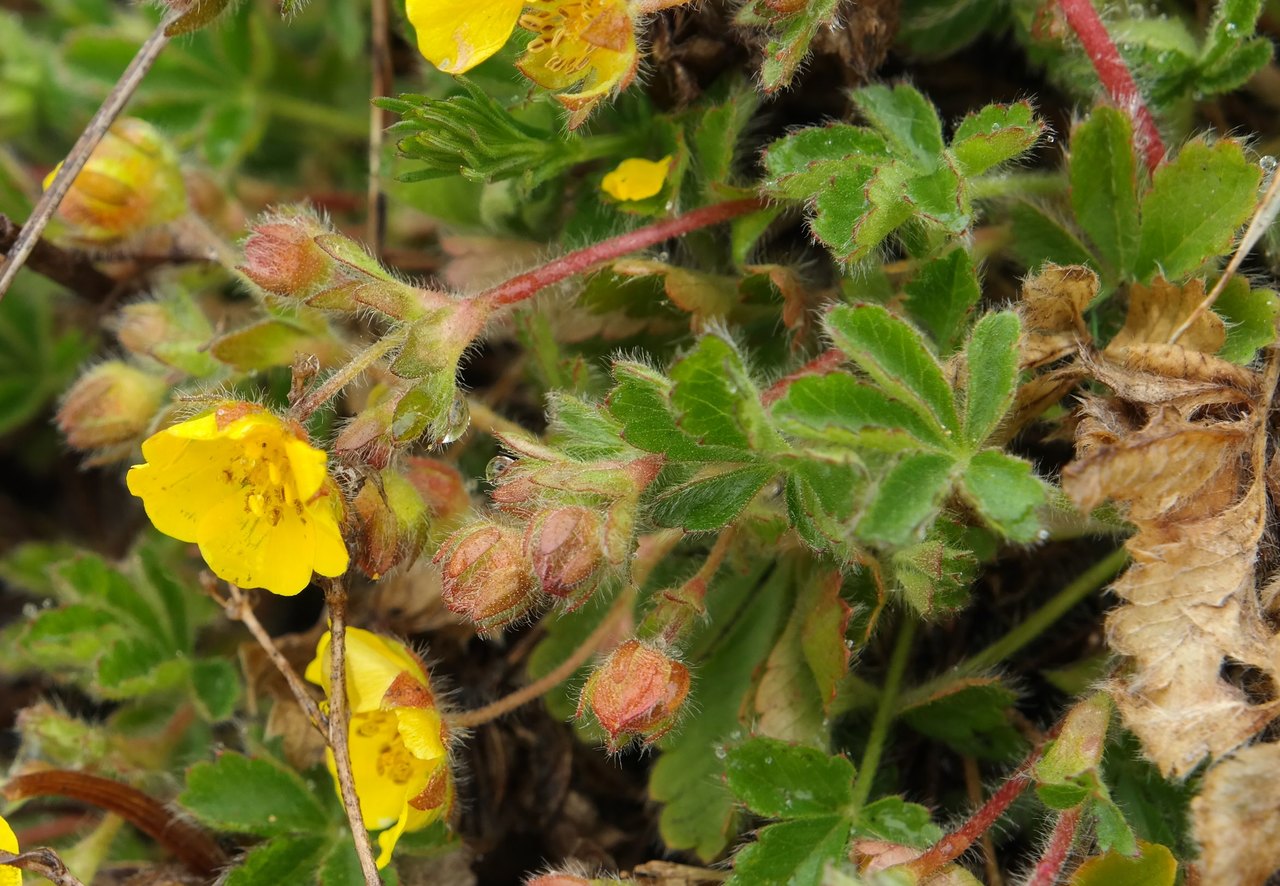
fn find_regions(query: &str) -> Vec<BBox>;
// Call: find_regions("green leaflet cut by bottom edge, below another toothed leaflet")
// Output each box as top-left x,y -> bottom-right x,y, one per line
728,816 -> 850,886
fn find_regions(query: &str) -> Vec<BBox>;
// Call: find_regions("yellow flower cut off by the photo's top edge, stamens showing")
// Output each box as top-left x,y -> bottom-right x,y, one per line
404,0 -> 640,128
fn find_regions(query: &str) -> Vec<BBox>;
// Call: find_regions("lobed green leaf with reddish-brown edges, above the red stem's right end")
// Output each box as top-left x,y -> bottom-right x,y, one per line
764,86 -> 1044,261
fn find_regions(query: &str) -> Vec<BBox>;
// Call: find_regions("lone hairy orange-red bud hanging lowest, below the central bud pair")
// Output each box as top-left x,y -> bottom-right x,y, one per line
577,640 -> 689,750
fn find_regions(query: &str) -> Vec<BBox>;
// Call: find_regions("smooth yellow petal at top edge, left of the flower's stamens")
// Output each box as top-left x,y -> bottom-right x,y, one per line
404,0 -> 524,74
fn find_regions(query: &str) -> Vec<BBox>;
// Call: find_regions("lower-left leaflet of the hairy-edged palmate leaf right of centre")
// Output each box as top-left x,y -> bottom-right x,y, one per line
858,453 -> 955,545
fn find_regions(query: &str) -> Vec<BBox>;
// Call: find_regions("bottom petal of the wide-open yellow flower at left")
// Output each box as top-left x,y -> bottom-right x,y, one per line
196,495 -> 315,597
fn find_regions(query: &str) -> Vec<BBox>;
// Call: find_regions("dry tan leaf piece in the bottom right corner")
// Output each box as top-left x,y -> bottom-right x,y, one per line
1192,744 -> 1280,886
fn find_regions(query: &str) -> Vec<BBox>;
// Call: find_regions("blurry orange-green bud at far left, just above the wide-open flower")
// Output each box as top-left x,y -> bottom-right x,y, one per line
55,360 -> 169,451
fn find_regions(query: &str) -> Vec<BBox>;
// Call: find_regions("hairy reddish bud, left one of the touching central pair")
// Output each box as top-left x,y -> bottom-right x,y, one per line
434,521 -> 539,632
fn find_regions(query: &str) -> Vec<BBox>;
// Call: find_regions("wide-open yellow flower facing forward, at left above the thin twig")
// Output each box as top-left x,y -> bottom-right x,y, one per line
128,402 -> 347,595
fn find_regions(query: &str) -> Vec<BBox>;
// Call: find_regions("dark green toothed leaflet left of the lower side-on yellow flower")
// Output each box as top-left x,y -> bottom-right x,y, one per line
178,752 -> 332,837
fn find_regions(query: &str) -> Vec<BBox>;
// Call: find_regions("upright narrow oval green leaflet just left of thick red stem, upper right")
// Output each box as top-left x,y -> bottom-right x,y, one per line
1070,106 -> 1138,273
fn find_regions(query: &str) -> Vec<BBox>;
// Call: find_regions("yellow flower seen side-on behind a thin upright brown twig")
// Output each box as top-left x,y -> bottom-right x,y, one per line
306,627 -> 453,867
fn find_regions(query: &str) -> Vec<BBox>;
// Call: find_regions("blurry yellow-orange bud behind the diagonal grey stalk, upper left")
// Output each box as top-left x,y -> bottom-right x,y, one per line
45,118 -> 188,245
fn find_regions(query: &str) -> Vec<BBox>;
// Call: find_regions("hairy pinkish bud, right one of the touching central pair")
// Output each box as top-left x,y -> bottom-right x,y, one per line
525,507 -> 604,608
